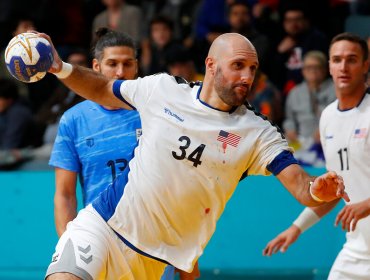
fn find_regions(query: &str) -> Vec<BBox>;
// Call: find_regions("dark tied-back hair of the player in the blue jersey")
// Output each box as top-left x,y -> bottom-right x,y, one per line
92,27 -> 137,60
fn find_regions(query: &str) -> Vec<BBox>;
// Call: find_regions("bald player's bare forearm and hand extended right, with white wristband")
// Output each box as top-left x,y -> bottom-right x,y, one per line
276,164 -> 349,206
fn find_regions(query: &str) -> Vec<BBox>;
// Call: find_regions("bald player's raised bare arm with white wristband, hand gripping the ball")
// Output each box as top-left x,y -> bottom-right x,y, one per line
33,31 -> 132,110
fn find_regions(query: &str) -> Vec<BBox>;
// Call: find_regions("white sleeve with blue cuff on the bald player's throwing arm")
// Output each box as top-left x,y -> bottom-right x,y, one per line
113,74 -> 164,111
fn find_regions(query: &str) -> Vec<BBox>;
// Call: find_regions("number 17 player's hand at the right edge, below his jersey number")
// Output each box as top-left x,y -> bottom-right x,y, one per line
335,198 -> 370,231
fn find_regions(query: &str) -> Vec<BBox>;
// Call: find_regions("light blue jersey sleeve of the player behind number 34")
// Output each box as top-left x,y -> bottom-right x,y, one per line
49,115 -> 81,173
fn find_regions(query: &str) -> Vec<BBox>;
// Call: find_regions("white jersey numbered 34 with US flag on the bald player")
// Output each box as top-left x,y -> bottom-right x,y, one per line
93,74 -> 290,271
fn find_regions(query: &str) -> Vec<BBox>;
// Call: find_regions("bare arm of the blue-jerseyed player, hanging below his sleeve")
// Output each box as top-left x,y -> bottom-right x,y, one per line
54,168 -> 77,237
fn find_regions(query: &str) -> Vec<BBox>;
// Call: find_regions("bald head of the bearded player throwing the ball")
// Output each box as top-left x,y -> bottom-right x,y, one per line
201,33 -> 258,111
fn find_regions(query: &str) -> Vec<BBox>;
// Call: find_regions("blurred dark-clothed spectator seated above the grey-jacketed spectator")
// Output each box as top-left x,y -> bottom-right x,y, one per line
271,5 -> 328,94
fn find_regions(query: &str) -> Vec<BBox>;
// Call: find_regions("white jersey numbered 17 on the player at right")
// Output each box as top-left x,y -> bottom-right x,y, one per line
320,94 -> 370,259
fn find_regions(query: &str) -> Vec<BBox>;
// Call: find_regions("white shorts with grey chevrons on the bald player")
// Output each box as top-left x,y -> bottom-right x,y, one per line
45,205 -> 166,280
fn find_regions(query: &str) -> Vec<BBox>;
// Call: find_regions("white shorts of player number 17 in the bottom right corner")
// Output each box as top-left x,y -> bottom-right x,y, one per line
328,248 -> 370,280
